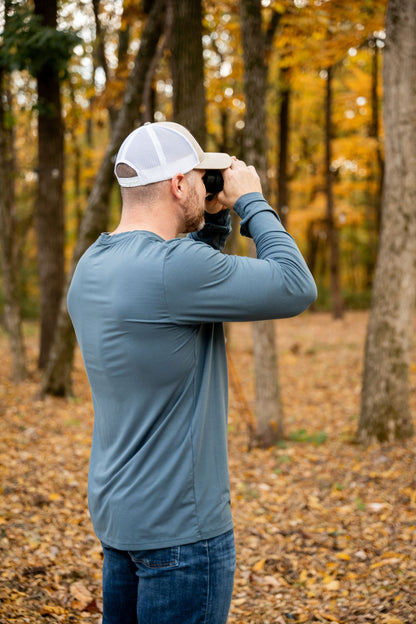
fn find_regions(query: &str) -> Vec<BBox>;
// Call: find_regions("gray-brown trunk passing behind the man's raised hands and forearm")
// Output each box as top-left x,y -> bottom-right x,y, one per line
241,0 -> 283,447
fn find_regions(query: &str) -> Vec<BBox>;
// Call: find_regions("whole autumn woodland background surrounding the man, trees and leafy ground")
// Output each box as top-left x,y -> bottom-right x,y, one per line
0,0 -> 416,624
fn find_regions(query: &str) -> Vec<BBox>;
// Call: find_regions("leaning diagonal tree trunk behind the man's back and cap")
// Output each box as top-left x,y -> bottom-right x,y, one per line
41,0 -> 165,396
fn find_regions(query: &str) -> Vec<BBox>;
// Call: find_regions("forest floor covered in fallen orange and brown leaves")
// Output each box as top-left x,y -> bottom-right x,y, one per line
0,312 -> 416,624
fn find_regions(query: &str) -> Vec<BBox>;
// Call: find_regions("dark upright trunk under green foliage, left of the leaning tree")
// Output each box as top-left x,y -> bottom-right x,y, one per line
35,0 -> 65,368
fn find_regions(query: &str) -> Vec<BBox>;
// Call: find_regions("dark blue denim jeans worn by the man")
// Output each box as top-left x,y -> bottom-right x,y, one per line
102,530 -> 235,624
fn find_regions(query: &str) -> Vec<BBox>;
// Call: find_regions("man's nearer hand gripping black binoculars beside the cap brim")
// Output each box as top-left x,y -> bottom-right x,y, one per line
218,157 -> 263,208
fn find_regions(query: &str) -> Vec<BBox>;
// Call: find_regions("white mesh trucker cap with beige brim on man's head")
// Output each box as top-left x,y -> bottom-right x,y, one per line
114,121 -> 231,187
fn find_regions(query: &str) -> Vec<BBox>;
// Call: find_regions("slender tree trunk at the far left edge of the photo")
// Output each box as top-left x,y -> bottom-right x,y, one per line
0,57 -> 27,383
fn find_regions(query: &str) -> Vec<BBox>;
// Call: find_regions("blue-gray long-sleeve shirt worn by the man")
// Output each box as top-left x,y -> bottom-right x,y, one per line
68,193 -> 316,550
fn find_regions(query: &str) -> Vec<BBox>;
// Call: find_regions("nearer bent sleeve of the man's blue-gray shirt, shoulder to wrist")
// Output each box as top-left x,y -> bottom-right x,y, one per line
164,193 -> 316,323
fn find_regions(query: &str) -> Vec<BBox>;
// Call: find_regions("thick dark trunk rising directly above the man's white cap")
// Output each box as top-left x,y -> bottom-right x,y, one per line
170,0 -> 206,147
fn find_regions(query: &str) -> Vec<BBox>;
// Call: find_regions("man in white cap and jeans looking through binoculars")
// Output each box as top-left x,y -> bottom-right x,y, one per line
68,122 -> 316,624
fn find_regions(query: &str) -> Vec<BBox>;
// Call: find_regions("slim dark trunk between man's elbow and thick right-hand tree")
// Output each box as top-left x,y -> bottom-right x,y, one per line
325,67 -> 343,319
